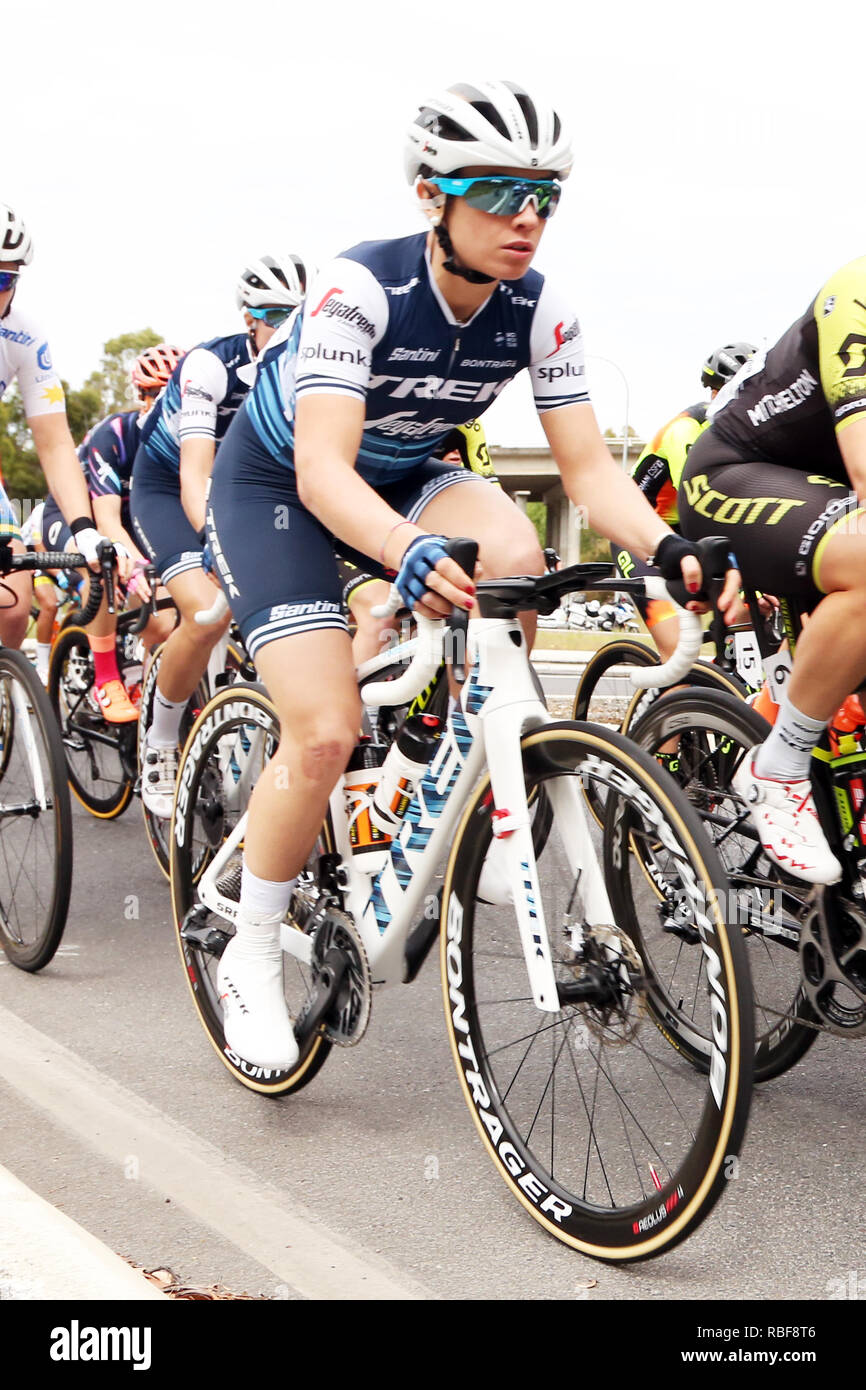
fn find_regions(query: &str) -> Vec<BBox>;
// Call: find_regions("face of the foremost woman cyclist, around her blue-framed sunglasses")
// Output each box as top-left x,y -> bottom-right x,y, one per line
439,168 -> 553,279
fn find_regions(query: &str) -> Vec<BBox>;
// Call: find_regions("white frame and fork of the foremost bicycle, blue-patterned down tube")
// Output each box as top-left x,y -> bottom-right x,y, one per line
199,619 -> 612,1011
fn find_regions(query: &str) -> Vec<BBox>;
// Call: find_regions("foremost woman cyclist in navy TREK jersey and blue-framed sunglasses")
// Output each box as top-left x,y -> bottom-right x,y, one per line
209,82 -> 717,1068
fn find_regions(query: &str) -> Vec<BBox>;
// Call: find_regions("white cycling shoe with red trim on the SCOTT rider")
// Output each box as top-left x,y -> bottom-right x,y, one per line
733,748 -> 842,884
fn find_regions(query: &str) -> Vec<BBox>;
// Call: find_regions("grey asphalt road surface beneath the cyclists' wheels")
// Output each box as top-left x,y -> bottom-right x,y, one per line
0,778 -> 866,1301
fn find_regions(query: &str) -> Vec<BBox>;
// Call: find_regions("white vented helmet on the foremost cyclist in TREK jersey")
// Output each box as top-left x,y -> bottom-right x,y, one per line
405,82 -> 573,183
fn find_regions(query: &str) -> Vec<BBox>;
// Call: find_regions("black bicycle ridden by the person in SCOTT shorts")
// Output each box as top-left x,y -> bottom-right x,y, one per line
631,594 -> 866,1080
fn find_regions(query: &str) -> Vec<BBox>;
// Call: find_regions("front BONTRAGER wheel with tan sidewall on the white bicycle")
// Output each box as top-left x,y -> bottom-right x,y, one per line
441,724 -> 753,1261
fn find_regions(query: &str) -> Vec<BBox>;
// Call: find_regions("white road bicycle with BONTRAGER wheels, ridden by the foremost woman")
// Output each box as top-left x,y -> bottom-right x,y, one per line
171,542 -> 753,1261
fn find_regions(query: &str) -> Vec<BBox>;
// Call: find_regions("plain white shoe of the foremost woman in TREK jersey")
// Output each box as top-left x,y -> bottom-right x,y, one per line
217,937 -> 299,1072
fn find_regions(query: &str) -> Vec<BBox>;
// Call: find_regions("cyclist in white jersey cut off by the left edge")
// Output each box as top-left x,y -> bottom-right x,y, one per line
0,203 -> 131,646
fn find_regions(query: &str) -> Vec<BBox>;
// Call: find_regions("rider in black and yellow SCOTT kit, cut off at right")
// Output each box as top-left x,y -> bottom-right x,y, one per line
680,256 -> 866,883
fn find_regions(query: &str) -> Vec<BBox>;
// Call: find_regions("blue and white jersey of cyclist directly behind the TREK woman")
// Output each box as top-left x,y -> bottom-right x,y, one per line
142,334 -> 256,473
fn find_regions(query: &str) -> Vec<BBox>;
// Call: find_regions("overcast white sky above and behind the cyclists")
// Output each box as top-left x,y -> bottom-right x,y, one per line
6,0 -> 866,443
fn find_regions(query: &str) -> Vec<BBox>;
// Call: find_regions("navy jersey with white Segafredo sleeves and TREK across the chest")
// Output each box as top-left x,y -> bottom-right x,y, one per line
243,232 -> 589,487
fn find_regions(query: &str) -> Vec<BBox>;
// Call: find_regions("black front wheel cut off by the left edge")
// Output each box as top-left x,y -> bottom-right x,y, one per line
0,648 -> 72,972
